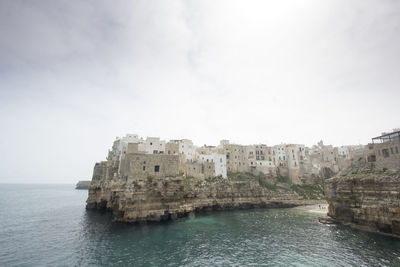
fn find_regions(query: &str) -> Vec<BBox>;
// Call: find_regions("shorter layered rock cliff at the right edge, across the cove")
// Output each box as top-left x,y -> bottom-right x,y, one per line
325,170 -> 400,238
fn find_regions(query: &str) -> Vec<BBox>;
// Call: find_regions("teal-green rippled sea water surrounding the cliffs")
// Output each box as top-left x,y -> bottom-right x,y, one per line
0,184 -> 400,266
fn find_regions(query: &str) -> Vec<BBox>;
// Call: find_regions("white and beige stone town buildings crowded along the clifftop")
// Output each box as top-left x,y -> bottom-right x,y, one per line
94,129 -> 400,184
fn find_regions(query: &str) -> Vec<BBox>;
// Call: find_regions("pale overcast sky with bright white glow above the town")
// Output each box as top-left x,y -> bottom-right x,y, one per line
0,0 -> 400,183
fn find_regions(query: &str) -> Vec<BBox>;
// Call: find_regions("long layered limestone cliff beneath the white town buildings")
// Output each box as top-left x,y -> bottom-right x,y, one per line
87,177 -> 315,222
